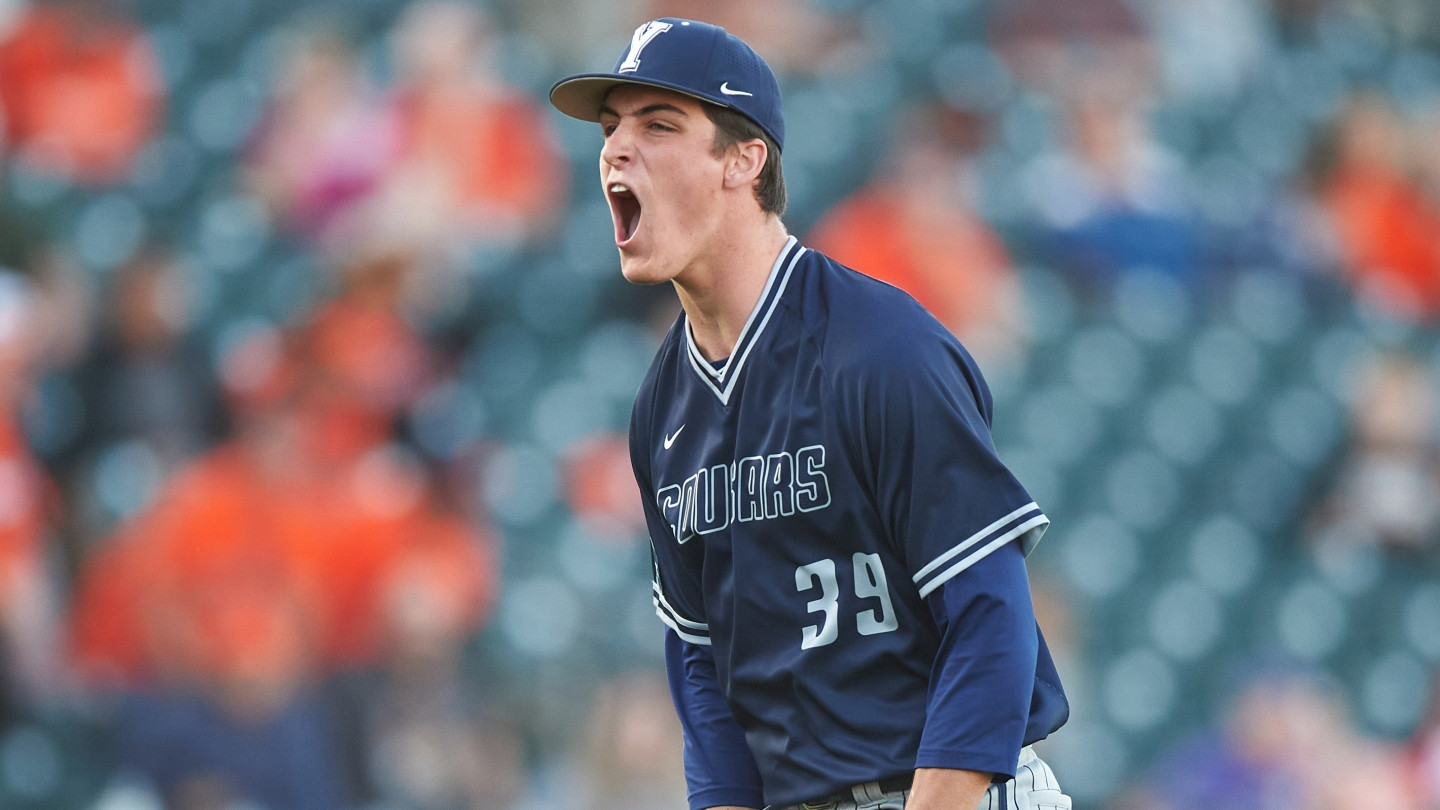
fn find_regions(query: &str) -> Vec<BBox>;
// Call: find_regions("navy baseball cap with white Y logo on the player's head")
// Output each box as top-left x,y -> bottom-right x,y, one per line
550,17 -> 785,148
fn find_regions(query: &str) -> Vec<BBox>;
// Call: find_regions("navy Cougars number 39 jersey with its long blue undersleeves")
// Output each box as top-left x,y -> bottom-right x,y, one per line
631,238 -> 1067,807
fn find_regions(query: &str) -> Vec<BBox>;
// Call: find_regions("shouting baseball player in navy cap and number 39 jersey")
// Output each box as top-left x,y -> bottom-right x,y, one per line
550,17 -> 1070,810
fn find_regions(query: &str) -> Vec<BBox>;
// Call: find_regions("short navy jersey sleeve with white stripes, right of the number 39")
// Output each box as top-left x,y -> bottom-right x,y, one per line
837,315 -> 1050,585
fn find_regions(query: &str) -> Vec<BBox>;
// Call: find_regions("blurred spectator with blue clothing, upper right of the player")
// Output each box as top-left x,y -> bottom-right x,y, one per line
988,0 -> 1198,288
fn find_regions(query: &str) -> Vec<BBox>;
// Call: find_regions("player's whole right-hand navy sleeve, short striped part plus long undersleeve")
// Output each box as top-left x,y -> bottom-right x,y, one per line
840,309 -> 1048,777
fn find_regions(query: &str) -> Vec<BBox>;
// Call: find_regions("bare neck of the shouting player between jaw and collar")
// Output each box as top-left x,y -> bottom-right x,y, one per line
674,215 -> 789,360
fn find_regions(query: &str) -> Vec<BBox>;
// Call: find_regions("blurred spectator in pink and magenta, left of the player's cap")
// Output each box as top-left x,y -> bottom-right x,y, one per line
245,29 -> 399,242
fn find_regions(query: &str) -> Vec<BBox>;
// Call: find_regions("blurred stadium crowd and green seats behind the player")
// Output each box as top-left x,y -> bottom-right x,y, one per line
0,0 -> 1440,810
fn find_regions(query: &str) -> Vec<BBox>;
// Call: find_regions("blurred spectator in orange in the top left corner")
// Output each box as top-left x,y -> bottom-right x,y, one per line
0,0 -> 163,186
